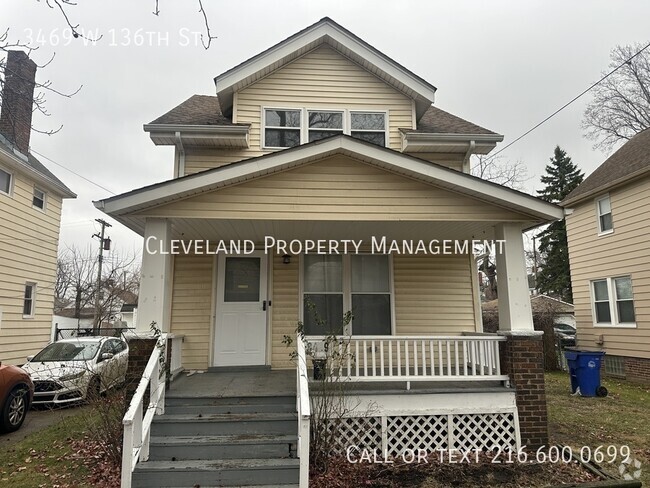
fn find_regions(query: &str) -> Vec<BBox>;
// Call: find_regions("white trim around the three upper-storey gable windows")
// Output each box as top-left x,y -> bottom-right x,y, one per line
260,105 -> 390,151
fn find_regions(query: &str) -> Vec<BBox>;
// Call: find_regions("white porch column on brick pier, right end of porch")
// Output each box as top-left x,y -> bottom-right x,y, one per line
495,223 -> 535,334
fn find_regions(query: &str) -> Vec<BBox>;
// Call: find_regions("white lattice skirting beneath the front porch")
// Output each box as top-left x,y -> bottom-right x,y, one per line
330,410 -> 519,457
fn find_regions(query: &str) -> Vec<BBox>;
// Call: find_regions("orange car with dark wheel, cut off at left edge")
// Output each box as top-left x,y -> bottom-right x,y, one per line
0,362 -> 34,432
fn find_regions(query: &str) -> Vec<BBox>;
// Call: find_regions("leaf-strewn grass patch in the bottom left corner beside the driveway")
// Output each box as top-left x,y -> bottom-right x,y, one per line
0,407 -> 93,488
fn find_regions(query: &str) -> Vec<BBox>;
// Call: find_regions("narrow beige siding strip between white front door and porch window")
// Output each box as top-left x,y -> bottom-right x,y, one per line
271,255 -> 299,369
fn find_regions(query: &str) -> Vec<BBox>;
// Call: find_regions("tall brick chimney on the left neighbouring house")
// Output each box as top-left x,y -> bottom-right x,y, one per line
0,51 -> 36,155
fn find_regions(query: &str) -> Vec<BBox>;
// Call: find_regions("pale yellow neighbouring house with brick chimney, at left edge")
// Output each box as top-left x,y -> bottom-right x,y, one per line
0,51 -> 76,364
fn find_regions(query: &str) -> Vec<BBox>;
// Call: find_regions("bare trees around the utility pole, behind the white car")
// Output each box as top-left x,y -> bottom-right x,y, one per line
55,246 -> 140,330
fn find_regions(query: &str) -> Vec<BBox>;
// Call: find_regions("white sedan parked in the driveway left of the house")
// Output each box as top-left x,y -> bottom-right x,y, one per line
23,337 -> 129,405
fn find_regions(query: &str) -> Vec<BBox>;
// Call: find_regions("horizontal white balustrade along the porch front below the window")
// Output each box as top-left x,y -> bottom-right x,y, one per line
307,335 -> 508,386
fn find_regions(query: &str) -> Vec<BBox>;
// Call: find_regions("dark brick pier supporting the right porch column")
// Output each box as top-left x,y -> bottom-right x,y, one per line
500,333 -> 548,448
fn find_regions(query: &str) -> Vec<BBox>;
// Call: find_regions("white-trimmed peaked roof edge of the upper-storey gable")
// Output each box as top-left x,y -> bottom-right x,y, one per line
214,17 -> 436,117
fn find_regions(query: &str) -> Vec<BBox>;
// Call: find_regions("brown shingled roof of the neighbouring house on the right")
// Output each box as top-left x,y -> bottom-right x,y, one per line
562,129 -> 650,206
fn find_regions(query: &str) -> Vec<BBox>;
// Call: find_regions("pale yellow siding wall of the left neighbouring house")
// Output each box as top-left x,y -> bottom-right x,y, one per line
0,171 -> 61,364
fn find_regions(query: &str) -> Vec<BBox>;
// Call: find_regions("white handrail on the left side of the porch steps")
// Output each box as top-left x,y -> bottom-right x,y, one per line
121,336 -> 169,488
